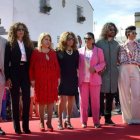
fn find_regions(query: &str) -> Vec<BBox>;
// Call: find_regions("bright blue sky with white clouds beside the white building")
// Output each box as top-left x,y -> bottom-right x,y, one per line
89,0 -> 140,38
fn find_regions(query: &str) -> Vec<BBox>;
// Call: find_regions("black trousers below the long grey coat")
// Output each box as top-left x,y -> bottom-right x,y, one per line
100,92 -> 114,121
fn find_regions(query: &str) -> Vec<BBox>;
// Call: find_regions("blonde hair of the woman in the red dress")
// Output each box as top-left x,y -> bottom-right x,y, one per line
37,33 -> 53,51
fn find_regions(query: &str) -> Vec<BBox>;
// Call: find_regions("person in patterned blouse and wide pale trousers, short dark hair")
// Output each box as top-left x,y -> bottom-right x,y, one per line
119,26 -> 140,124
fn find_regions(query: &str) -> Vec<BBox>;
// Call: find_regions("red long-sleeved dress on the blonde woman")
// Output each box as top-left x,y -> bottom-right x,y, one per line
30,50 -> 60,105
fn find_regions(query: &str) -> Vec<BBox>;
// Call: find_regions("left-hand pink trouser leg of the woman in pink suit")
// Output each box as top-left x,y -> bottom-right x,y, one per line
79,83 -> 89,124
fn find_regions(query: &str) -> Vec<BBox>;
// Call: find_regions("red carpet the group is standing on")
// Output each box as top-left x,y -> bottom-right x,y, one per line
0,115 -> 140,140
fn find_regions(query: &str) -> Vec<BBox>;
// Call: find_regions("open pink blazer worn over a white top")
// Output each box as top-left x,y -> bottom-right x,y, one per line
78,46 -> 105,86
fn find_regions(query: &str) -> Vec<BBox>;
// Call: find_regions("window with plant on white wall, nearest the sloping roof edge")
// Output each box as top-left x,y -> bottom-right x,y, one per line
77,6 -> 86,23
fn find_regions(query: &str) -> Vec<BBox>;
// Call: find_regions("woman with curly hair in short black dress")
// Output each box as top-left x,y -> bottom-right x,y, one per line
57,32 -> 79,130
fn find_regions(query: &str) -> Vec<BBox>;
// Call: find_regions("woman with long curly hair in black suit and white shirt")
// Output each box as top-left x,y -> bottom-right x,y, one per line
4,22 -> 33,134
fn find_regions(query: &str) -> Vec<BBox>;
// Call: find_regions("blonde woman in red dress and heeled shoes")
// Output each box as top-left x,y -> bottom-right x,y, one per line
30,33 -> 60,131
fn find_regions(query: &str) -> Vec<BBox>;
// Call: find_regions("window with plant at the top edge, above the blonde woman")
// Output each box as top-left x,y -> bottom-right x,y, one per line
40,0 -> 52,14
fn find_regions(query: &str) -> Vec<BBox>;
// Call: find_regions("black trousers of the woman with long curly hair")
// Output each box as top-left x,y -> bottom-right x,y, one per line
11,64 -> 30,131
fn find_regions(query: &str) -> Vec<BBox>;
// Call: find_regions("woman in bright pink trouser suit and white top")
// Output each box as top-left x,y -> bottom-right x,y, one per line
79,32 -> 105,128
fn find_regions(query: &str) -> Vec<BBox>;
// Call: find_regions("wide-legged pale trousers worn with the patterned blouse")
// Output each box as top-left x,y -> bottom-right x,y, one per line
118,64 -> 140,124
